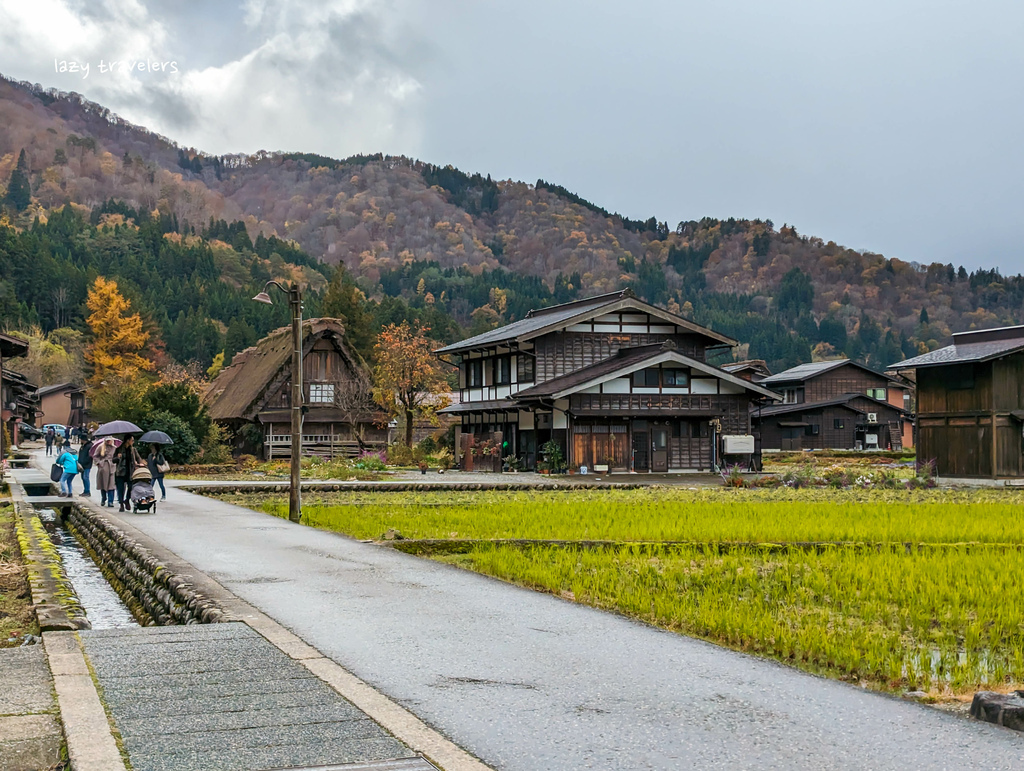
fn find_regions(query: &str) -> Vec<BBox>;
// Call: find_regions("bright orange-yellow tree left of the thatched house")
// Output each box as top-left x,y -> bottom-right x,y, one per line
85,275 -> 153,387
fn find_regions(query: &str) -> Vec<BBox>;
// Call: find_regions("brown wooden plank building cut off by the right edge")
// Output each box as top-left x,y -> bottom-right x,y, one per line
892,327 -> 1024,479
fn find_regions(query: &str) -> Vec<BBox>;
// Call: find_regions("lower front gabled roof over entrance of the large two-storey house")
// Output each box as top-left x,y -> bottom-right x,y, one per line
511,342 -> 781,401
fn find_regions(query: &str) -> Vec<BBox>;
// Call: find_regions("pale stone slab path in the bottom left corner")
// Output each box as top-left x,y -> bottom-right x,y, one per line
0,645 -> 63,771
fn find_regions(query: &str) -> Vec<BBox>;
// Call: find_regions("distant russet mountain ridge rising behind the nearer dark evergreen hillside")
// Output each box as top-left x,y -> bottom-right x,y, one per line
0,70 -> 1024,367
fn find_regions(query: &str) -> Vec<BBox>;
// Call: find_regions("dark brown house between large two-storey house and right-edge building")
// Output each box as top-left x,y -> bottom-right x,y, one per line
754,358 -> 913,452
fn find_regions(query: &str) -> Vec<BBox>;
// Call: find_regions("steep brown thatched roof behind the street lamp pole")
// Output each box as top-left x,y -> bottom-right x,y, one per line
203,318 -> 370,420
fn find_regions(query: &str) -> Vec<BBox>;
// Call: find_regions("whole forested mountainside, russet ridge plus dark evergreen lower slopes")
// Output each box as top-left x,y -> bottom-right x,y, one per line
0,70 -> 1024,376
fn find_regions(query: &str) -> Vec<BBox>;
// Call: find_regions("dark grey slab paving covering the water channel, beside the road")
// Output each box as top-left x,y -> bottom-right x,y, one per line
80,623 -> 433,771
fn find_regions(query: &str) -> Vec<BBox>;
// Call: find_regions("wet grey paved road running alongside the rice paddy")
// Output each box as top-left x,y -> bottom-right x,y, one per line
101,481 -> 1024,771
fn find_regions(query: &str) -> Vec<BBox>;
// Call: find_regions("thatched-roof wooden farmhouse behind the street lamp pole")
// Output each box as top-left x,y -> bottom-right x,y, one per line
204,318 -> 387,460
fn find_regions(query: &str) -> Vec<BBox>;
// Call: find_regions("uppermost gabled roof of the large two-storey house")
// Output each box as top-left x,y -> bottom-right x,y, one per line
434,289 -> 736,354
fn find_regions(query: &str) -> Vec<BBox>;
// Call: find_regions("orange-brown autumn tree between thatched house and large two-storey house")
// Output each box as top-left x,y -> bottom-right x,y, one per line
374,322 -> 449,446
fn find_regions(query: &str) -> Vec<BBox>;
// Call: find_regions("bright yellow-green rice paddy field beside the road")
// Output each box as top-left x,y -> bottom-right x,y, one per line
214,487 -> 1024,701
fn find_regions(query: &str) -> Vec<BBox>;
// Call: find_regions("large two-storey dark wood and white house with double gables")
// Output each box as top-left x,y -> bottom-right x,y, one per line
436,291 -> 779,472
